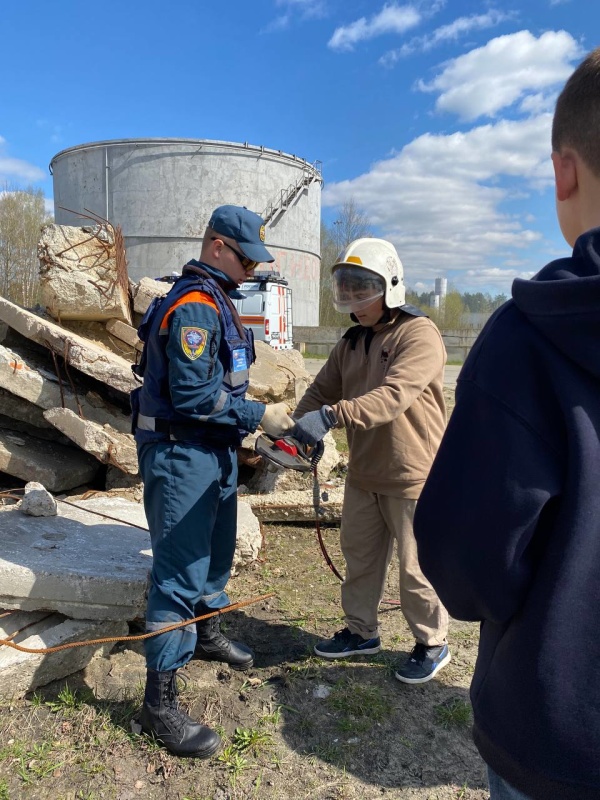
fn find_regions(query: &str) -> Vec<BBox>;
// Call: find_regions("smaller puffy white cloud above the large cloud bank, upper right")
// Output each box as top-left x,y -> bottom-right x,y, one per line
417,31 -> 581,120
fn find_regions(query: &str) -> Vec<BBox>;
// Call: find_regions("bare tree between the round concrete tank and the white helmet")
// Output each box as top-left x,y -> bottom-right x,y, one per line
319,198 -> 373,327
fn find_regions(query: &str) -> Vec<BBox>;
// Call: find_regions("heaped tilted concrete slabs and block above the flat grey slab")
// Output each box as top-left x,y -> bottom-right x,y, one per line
0,223 -> 337,500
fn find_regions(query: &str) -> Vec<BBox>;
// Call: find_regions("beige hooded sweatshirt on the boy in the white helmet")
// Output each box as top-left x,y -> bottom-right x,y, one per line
294,311 -> 446,498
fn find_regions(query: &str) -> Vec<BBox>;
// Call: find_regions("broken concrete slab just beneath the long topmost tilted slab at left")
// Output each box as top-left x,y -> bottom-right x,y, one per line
0,342 -> 131,433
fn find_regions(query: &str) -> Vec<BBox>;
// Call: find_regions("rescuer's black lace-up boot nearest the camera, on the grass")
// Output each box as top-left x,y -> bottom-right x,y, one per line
139,669 -> 221,758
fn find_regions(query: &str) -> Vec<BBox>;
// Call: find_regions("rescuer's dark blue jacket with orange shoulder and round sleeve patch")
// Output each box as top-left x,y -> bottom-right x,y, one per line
132,261 -> 265,447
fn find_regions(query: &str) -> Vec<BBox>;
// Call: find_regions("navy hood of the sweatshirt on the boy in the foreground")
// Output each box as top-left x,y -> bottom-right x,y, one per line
512,228 -> 600,378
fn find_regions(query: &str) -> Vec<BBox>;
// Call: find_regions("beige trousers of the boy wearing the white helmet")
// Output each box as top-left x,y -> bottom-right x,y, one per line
341,482 -> 448,647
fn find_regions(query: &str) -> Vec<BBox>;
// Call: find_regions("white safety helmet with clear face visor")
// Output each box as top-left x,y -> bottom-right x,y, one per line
332,237 -> 406,313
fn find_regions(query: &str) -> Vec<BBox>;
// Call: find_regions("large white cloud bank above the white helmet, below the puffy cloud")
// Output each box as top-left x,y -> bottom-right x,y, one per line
323,114 -> 552,291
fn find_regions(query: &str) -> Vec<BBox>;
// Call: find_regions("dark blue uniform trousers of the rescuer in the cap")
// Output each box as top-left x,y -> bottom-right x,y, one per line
138,442 -> 237,672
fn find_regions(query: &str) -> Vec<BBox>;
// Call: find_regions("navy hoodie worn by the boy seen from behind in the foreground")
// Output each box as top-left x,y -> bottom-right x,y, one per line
415,228 -> 600,800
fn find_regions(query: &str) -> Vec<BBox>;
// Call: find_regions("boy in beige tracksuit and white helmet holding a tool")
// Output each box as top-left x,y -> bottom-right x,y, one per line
291,238 -> 450,683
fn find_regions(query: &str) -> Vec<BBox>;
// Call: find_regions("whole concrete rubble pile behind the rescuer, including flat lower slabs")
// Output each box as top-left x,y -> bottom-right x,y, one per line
0,221 -> 342,697
